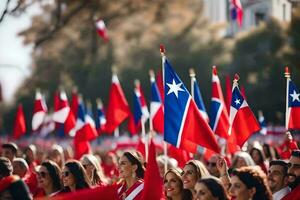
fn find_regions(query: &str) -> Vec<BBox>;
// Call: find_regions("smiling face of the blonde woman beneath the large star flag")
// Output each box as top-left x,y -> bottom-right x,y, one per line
181,164 -> 197,190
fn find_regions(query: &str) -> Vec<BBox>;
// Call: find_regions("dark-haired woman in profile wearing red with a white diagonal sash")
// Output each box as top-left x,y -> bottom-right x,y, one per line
118,152 -> 145,200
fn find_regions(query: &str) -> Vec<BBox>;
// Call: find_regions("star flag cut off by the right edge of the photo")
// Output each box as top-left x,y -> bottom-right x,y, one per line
287,78 -> 300,129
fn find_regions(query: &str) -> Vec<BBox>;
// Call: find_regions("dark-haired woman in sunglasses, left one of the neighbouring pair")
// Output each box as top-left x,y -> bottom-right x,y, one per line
36,160 -> 63,197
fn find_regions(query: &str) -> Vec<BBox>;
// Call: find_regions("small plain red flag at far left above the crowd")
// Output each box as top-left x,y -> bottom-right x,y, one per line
12,104 -> 26,139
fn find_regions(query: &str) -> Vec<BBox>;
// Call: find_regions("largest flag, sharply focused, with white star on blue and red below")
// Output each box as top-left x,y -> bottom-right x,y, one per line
163,57 -> 219,153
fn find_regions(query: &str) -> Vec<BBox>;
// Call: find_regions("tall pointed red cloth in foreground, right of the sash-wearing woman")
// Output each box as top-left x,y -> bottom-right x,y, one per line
142,140 -> 163,200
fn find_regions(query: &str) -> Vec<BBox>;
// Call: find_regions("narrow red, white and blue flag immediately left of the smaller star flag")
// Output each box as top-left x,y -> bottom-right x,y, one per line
210,66 -> 229,139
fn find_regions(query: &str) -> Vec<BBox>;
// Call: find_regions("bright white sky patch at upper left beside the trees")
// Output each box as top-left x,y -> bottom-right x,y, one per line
0,0 -> 39,103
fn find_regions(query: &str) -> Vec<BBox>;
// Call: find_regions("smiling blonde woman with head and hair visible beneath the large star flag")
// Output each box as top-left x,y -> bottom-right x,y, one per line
181,160 -> 210,197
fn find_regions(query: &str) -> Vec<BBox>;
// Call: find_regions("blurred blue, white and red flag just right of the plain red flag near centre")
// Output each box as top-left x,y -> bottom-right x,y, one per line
128,80 -> 149,134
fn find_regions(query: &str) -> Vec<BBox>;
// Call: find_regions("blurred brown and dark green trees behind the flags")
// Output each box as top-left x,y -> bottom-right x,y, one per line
0,0 -> 300,134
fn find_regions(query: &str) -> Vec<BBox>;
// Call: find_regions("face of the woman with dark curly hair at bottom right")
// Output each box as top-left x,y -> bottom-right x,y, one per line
229,176 -> 252,200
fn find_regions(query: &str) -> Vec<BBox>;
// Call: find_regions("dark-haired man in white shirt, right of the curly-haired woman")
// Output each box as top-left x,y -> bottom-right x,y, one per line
268,160 -> 291,200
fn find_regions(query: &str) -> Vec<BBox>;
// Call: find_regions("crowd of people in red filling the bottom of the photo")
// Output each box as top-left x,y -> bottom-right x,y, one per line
0,132 -> 300,200
